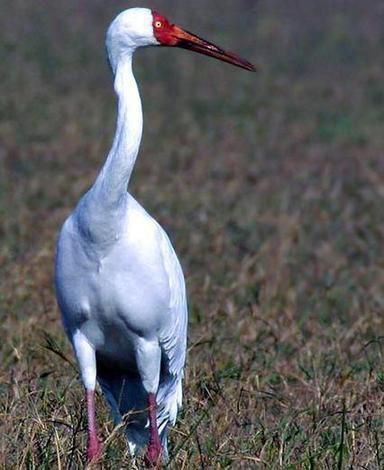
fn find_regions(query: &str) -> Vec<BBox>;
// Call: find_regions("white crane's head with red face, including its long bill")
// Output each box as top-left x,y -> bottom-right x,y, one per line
106,8 -> 256,71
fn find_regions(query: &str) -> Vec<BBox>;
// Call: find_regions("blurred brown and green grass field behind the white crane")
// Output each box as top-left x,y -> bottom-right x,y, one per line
0,0 -> 384,470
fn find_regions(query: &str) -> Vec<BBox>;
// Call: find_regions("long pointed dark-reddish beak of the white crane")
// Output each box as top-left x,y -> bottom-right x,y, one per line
172,25 -> 256,72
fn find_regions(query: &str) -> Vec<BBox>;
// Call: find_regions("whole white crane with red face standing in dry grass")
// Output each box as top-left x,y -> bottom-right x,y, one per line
55,8 -> 254,466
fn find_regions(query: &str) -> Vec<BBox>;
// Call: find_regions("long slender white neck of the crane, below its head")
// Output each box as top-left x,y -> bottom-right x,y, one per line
92,54 -> 143,207
